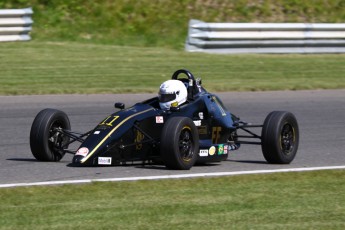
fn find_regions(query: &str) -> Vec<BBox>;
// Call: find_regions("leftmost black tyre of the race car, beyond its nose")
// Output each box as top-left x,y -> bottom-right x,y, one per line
30,109 -> 71,161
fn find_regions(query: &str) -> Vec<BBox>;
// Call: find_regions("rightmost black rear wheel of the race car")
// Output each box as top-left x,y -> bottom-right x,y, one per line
261,111 -> 299,164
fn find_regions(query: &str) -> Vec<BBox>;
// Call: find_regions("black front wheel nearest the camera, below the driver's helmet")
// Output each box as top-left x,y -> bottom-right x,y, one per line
160,117 -> 199,170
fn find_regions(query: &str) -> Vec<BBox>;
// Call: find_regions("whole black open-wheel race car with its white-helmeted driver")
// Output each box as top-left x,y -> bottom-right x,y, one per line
30,69 -> 299,170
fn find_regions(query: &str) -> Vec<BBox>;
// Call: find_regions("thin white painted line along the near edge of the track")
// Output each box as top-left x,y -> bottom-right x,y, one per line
0,165 -> 345,188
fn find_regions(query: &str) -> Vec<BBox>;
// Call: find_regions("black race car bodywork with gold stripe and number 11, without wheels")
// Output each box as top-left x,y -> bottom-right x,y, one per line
73,70 -> 240,165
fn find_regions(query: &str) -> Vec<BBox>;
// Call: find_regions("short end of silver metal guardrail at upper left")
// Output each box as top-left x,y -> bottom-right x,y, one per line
0,8 -> 33,42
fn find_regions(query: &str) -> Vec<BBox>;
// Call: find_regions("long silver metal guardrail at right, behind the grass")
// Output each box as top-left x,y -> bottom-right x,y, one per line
185,19 -> 345,53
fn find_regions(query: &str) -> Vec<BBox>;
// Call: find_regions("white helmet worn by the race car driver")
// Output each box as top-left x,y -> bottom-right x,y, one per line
158,80 -> 187,110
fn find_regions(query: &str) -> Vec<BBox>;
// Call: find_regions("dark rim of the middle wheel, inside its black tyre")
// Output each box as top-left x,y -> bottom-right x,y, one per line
179,127 -> 194,161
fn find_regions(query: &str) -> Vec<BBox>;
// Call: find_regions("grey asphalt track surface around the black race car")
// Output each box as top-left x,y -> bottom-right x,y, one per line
0,90 -> 345,185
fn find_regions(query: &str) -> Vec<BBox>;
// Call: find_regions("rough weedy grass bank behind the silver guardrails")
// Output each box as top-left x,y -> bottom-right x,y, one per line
0,0 -> 345,50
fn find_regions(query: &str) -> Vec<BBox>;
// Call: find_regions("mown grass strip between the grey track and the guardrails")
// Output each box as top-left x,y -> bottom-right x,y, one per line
0,41 -> 345,95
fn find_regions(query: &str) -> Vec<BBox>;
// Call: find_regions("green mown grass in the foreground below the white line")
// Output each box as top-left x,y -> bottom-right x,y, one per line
0,170 -> 345,230
